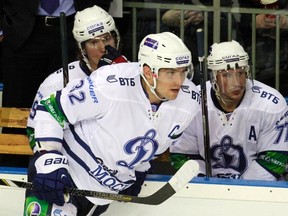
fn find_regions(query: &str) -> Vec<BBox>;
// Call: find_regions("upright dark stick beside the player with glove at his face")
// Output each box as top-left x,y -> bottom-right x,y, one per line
60,12 -> 69,87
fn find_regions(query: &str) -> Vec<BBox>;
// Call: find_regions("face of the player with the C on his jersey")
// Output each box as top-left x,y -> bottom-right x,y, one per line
156,67 -> 188,100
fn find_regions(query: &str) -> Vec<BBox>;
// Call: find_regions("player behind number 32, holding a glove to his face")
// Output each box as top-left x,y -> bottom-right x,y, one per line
27,5 -> 127,152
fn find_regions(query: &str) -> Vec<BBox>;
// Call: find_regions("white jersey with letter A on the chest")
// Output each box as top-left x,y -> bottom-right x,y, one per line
170,80 -> 288,180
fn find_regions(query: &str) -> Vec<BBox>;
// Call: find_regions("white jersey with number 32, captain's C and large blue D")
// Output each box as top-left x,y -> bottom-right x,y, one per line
35,63 -> 200,204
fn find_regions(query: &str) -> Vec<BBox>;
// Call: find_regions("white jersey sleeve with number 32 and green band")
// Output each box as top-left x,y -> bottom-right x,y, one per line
35,77 -> 112,147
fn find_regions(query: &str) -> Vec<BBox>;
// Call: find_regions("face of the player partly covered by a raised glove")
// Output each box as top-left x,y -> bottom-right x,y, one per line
84,33 -> 116,70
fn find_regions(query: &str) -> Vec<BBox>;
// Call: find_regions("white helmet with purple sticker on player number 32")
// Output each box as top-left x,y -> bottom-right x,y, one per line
138,32 -> 193,77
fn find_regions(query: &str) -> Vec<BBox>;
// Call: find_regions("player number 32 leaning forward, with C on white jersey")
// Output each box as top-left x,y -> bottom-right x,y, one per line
24,32 -> 200,215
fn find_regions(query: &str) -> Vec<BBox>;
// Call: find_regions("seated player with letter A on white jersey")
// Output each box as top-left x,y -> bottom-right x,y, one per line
170,41 -> 288,181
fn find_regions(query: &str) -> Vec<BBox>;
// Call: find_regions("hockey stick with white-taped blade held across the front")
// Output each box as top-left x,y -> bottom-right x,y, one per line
0,160 -> 199,205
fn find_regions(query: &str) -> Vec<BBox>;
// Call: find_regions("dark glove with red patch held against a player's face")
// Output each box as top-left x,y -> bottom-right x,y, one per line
98,45 -> 128,68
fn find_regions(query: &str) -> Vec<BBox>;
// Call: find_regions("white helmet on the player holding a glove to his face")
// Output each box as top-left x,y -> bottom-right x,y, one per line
73,5 -> 120,49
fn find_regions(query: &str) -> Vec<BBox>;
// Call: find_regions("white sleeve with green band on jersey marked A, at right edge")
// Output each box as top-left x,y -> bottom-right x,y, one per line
242,92 -> 288,180
